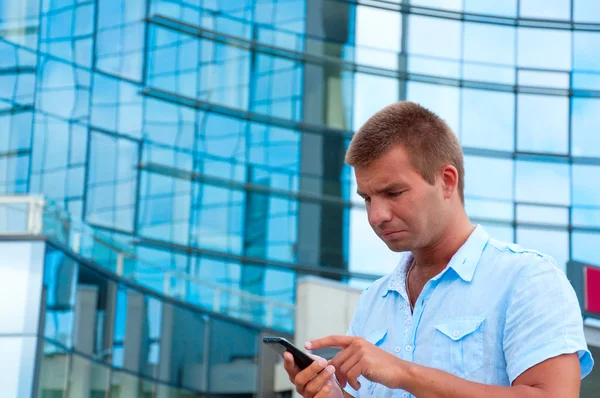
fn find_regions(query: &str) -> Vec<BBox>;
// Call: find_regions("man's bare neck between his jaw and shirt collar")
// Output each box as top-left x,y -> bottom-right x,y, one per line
412,214 -> 475,274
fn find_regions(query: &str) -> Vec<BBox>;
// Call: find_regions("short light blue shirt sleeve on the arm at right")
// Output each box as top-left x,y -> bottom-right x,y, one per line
503,256 -> 594,384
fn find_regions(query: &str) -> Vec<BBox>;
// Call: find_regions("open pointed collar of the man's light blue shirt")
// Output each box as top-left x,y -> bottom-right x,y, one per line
384,225 -> 490,296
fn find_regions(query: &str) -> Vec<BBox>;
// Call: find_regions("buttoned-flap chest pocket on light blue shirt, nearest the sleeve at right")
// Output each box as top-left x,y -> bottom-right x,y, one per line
432,316 -> 485,377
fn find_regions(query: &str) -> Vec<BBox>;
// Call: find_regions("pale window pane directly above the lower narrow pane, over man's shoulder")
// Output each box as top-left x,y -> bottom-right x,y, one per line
516,160 -> 570,206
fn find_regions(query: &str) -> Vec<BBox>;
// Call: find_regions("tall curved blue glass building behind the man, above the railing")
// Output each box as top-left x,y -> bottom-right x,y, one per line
0,0 -> 600,396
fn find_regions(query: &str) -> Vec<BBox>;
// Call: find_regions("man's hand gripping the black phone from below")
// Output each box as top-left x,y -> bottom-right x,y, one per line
283,352 -> 344,398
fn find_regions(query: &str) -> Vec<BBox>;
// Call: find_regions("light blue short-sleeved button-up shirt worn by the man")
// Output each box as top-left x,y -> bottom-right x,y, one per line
345,226 -> 594,398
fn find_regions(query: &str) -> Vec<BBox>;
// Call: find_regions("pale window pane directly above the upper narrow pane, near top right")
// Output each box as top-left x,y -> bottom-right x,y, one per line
517,28 -> 571,71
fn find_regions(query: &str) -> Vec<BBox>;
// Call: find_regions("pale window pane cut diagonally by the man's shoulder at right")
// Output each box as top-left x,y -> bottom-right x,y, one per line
517,227 -> 569,271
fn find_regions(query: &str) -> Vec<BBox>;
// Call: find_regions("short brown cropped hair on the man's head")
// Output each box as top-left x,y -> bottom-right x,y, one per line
345,101 -> 465,204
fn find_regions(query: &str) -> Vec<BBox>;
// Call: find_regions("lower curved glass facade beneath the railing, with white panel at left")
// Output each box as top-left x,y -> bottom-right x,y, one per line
0,241 -> 272,398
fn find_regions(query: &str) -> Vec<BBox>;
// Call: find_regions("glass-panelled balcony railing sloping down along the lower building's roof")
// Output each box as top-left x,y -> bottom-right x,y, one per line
0,196 -> 295,332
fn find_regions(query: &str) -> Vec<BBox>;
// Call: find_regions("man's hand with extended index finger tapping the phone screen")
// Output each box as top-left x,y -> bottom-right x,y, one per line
305,336 -> 406,390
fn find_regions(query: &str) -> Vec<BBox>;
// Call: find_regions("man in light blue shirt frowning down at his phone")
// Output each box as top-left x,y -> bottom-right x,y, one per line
284,102 -> 593,398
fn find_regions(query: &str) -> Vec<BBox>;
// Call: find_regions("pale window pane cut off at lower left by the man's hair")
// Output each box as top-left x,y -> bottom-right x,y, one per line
407,81 -> 460,134
